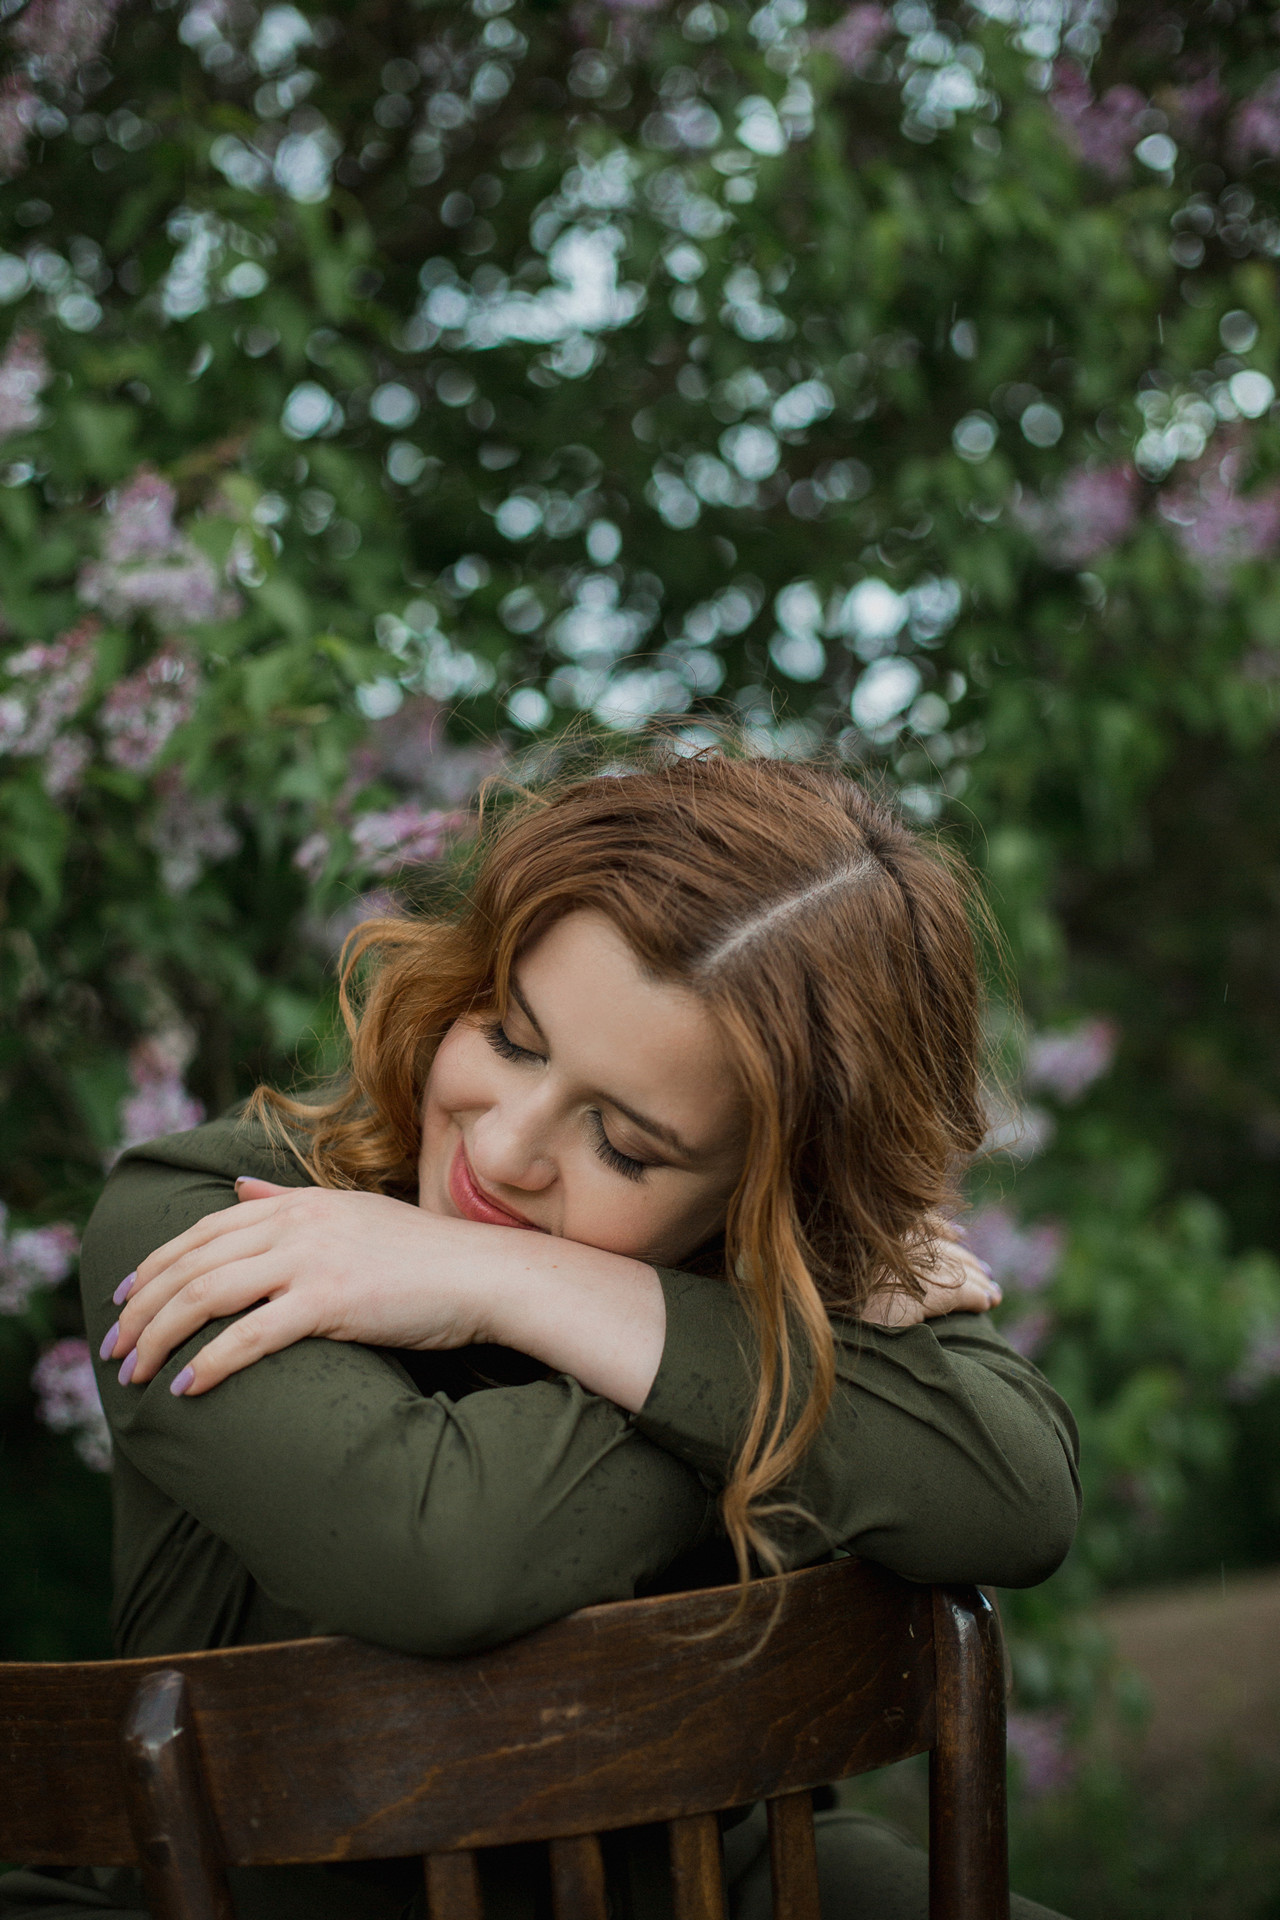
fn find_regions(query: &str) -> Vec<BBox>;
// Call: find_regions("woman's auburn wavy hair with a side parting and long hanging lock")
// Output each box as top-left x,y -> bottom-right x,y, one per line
255,751 -> 984,1578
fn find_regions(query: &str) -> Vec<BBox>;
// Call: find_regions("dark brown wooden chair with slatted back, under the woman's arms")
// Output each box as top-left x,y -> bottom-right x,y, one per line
0,1559 -> 1009,1920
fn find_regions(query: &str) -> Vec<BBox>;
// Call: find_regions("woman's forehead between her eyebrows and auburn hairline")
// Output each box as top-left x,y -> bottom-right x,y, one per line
514,912 -> 737,1146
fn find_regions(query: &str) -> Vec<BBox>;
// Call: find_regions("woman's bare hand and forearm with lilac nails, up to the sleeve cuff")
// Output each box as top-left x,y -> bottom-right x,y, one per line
102,1179 -> 666,1413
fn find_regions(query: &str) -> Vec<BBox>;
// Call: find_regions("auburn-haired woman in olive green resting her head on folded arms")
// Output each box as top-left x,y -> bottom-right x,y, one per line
6,755 -> 1077,1920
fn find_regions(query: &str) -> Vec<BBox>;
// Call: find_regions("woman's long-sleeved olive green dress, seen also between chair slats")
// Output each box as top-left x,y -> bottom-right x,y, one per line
0,1116 -> 1079,1920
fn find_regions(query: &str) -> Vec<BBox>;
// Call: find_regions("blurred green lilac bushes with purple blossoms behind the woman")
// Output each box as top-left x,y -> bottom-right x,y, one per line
0,0 -> 1280,1774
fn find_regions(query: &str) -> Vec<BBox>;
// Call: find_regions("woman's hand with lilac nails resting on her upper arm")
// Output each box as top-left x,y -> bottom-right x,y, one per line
102,1179 -> 510,1394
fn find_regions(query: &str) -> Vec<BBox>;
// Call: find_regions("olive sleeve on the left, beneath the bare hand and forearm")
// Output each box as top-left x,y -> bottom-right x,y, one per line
83,1129 -> 714,1655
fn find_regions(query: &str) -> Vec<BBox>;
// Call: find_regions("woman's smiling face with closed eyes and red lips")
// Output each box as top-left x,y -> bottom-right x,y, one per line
418,912 -> 745,1265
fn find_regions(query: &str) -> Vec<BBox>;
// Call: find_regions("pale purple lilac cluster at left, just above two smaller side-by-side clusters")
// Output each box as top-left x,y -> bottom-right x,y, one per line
79,467 -> 240,626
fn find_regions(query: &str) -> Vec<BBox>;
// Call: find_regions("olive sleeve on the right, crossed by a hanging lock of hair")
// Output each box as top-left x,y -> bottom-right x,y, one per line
635,1271 -> 1080,1586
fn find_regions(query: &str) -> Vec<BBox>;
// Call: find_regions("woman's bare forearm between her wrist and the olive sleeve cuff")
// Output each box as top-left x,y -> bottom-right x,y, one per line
476,1227 -> 666,1413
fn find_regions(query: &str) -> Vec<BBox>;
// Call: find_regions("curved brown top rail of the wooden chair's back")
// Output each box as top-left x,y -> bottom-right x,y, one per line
0,1559 -> 935,1866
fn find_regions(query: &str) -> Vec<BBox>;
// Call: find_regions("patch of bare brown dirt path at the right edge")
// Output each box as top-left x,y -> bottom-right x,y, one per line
1100,1571 -> 1280,1782
